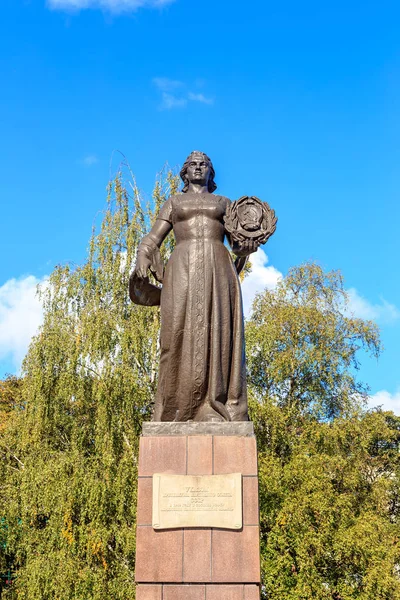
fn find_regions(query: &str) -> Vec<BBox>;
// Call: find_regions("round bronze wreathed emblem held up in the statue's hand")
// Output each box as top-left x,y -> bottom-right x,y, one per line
224,196 -> 278,246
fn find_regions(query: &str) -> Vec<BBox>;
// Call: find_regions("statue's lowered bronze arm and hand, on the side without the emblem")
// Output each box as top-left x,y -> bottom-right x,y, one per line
135,219 -> 172,281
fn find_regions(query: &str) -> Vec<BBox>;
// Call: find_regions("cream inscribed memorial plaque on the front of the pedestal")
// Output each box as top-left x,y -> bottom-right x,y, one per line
153,473 -> 242,529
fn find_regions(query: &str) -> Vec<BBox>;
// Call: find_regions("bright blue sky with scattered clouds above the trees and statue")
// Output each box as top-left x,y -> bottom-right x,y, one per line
0,0 -> 400,413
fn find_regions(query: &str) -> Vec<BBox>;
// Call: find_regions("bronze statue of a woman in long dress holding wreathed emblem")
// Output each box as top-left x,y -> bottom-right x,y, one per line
130,152 -> 276,421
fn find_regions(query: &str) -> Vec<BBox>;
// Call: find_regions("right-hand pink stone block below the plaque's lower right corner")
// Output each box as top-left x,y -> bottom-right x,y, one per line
211,526 -> 260,583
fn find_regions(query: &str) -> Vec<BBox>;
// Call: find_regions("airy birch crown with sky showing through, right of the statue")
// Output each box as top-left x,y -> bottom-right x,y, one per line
246,263 -> 380,419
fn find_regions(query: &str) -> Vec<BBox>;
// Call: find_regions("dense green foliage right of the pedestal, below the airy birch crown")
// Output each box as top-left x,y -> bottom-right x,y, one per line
253,407 -> 400,600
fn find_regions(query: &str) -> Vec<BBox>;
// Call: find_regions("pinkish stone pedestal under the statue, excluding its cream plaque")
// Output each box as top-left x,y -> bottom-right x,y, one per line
135,423 -> 260,600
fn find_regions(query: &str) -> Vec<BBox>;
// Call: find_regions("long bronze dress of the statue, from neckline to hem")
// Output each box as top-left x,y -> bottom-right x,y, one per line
153,193 -> 248,421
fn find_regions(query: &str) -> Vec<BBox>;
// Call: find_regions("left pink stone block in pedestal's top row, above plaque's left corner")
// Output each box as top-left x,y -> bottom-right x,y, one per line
139,436 -> 186,477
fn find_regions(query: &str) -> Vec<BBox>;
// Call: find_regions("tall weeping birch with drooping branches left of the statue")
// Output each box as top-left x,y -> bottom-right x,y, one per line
0,165 -> 177,600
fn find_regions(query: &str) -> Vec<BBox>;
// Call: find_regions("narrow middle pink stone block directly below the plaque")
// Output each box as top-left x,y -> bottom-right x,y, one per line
183,529 -> 211,583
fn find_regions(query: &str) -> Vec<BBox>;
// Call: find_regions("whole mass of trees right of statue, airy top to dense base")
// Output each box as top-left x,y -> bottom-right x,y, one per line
247,264 -> 400,600
